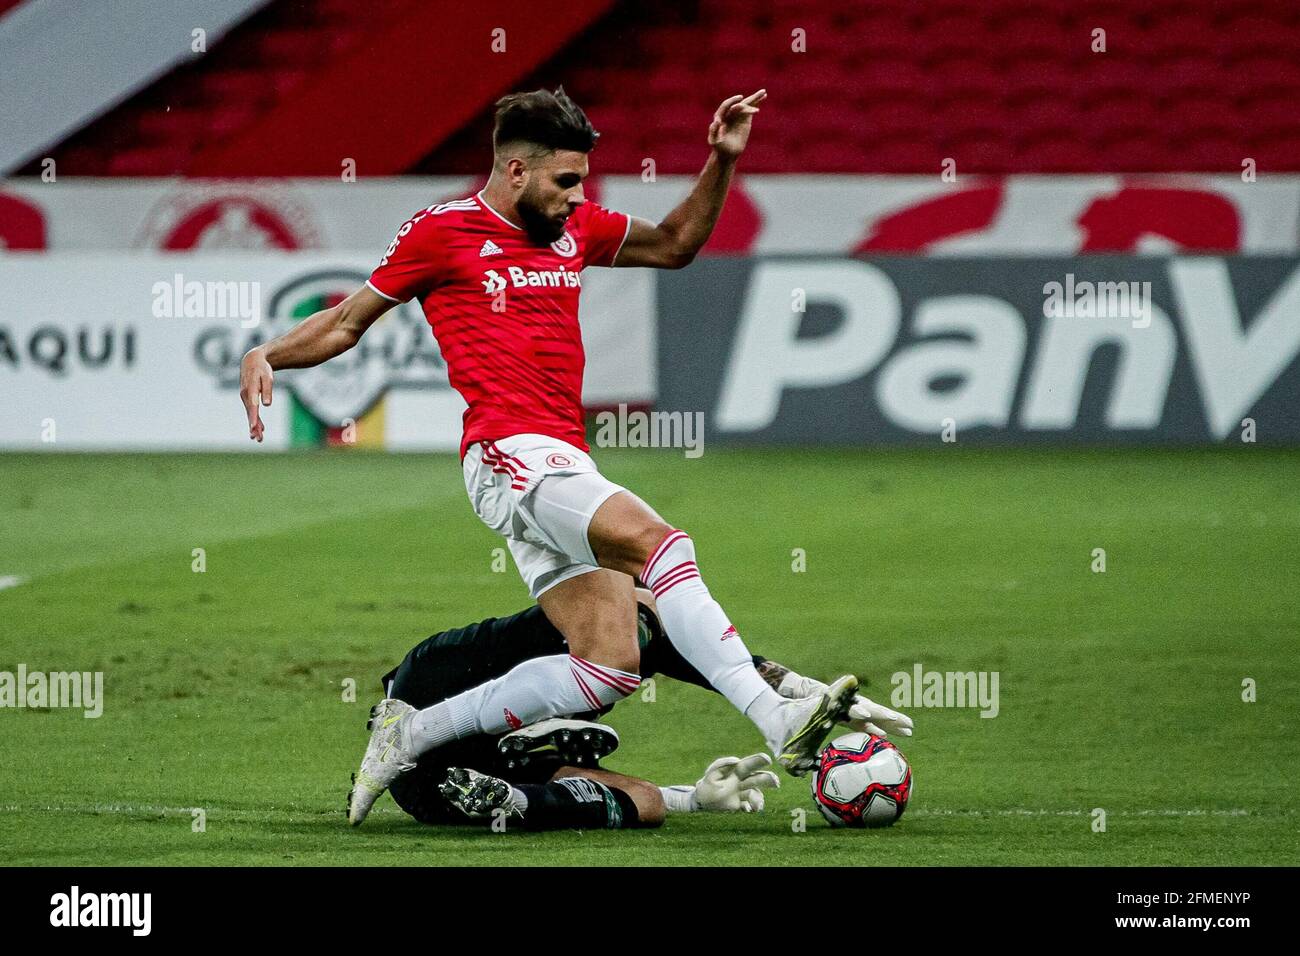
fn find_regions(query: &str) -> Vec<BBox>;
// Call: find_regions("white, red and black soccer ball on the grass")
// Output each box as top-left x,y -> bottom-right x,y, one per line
813,734 -> 911,827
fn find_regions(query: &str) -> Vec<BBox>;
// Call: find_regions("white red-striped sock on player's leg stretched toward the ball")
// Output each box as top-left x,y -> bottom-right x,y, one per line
641,531 -> 783,741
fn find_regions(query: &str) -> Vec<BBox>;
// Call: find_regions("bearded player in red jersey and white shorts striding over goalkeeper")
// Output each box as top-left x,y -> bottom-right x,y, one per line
241,88 -> 878,825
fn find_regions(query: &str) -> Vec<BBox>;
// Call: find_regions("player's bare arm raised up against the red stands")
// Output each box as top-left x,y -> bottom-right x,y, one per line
614,90 -> 767,269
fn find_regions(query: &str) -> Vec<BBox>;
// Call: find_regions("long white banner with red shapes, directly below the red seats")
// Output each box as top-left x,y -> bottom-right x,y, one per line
0,175 -> 1300,260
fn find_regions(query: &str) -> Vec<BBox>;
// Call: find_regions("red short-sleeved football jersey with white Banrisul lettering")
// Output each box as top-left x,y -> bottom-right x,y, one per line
368,193 -> 632,458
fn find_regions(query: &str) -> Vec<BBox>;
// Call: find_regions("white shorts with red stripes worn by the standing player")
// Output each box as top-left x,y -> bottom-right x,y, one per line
463,434 -> 624,600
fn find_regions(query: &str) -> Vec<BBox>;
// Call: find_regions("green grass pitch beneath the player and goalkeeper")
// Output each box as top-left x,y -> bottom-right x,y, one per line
0,446 -> 1300,866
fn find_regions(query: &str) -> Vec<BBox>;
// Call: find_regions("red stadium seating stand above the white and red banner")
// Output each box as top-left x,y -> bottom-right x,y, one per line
10,0 -> 1300,176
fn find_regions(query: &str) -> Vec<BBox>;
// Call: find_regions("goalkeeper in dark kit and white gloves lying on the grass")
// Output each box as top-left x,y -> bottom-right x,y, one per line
361,589 -> 911,830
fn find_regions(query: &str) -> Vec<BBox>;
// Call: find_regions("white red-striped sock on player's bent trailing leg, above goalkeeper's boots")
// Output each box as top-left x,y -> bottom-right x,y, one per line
411,654 -> 641,753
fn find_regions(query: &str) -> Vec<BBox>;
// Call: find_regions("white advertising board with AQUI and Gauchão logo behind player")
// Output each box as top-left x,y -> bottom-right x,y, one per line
0,252 -> 655,450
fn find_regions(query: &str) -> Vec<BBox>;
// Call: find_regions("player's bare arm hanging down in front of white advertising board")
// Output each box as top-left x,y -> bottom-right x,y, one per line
239,286 -> 397,441
